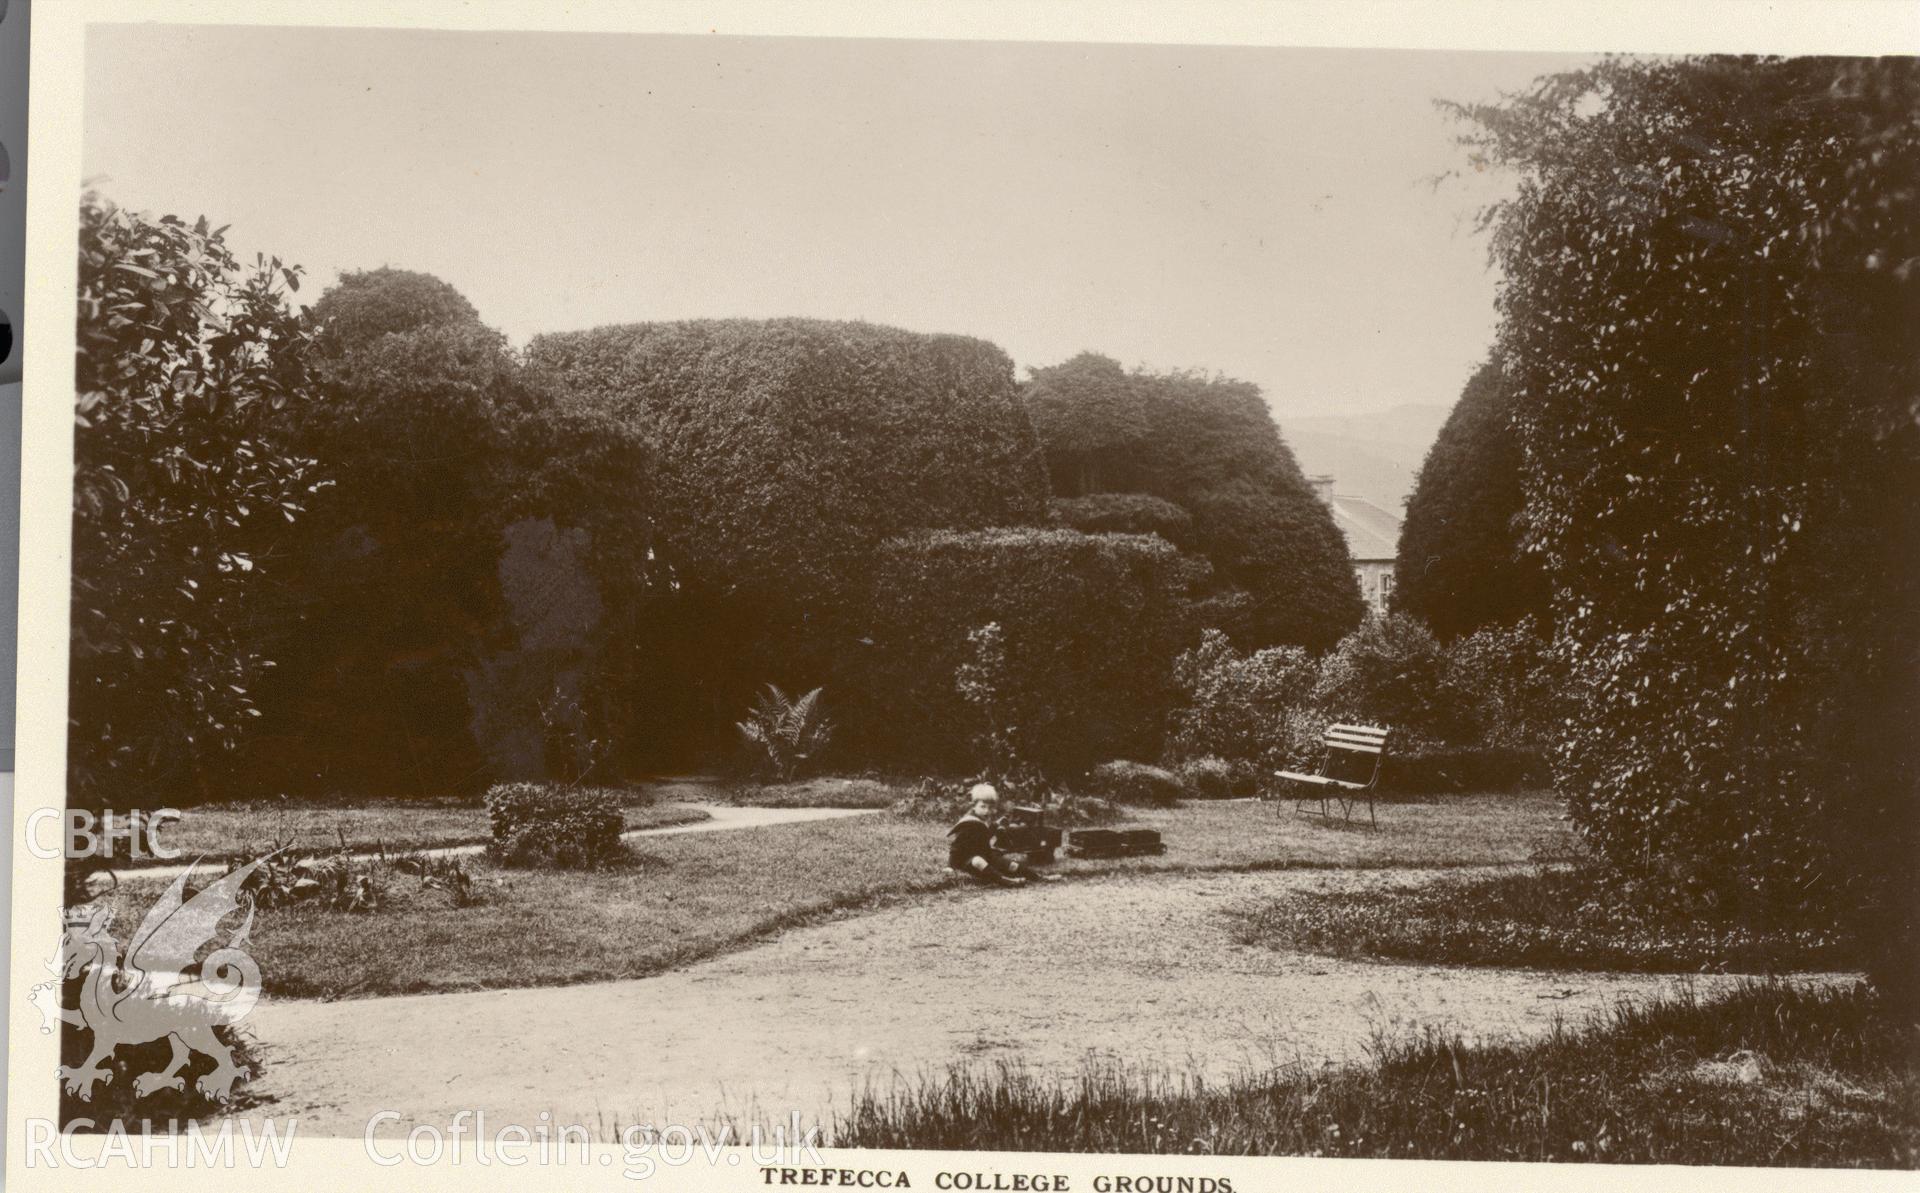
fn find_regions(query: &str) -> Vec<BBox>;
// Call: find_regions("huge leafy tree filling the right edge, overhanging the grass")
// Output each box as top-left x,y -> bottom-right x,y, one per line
1459,58 -> 1920,991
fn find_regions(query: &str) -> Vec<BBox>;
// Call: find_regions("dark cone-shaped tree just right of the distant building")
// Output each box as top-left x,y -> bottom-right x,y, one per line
1394,361 -> 1548,640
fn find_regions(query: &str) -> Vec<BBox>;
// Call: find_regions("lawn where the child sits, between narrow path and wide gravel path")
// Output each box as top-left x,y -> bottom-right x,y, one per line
115,795 -> 1572,997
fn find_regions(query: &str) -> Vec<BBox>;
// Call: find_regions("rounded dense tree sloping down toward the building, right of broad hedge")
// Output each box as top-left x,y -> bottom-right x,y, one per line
1023,353 -> 1363,649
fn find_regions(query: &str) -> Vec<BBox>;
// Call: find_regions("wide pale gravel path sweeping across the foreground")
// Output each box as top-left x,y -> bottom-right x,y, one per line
250,870 -> 1827,1135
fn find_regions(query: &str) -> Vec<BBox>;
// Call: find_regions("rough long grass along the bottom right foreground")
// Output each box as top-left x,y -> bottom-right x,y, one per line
828,984 -> 1920,1168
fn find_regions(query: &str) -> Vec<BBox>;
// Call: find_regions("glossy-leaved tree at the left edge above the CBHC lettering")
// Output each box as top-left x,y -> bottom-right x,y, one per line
67,194 -> 317,805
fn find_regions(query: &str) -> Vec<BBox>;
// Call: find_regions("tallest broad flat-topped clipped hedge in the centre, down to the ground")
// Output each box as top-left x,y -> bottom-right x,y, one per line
528,319 -> 1046,765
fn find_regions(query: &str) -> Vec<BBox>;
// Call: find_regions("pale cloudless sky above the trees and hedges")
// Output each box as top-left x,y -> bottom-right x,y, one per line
84,25 -> 1584,415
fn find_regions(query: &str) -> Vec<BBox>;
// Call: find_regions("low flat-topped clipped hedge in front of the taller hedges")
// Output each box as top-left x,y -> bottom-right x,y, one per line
837,528 -> 1194,772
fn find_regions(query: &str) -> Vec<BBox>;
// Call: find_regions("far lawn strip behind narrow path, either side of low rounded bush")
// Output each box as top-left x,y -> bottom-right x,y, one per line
134,790 -> 708,866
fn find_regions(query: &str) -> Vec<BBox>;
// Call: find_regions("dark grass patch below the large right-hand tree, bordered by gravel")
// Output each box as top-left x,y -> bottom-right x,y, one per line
1236,866 -> 1862,974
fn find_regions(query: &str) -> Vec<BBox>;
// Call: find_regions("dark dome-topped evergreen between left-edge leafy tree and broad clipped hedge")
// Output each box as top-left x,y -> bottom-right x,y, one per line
248,269 -> 529,797
